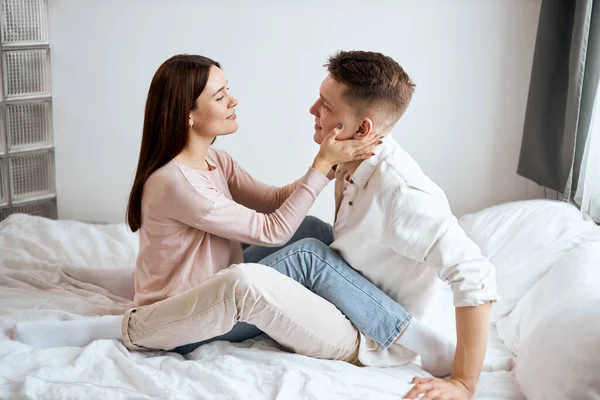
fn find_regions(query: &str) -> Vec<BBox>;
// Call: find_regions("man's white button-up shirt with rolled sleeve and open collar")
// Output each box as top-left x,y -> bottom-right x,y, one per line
331,134 -> 498,366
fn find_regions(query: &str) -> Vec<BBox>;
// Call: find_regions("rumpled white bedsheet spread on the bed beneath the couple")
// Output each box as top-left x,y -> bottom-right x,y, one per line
0,215 -> 524,400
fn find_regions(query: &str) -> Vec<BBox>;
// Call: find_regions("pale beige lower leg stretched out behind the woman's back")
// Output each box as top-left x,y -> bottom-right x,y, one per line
61,265 -> 135,300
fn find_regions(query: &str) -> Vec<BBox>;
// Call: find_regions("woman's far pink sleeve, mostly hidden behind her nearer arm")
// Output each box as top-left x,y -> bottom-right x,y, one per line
223,153 -> 303,214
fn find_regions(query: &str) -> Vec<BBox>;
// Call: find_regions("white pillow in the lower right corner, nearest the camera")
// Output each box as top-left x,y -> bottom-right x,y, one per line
497,241 -> 600,399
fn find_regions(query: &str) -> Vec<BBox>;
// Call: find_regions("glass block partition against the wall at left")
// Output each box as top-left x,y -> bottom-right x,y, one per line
0,0 -> 57,220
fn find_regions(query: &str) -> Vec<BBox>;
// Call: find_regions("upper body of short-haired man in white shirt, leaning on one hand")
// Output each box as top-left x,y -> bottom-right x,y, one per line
310,51 -> 498,398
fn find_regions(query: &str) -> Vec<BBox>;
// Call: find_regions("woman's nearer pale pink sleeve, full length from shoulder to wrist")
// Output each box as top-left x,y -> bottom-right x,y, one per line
161,168 -> 329,246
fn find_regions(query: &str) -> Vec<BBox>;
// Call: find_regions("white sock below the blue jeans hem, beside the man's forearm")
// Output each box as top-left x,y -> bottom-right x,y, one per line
396,318 -> 456,377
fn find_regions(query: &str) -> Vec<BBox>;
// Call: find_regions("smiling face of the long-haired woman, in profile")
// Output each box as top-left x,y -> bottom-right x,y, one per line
188,65 -> 238,137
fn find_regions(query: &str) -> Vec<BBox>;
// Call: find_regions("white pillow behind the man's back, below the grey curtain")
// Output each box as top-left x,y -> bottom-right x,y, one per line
460,200 -> 590,322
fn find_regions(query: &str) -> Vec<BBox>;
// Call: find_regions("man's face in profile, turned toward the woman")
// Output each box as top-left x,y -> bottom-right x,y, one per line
310,75 -> 360,144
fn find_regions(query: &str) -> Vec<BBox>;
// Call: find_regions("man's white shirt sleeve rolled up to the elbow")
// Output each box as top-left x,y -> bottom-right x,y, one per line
387,184 -> 498,307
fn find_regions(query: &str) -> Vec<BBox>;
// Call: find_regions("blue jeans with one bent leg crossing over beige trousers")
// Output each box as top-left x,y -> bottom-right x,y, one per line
173,216 -> 412,354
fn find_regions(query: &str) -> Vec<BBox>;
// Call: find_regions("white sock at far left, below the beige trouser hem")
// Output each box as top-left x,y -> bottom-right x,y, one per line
15,315 -> 123,349
